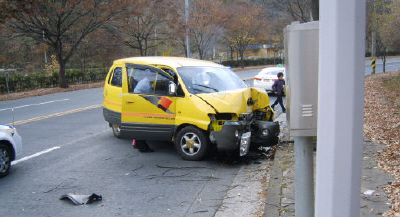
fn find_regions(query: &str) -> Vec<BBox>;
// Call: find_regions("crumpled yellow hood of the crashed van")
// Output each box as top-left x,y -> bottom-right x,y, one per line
197,88 -> 269,115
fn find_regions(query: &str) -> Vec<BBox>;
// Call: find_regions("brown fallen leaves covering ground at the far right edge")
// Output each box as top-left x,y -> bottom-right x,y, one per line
364,71 -> 400,216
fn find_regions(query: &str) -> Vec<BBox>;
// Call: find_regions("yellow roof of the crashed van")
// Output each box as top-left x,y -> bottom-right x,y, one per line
114,56 -> 225,68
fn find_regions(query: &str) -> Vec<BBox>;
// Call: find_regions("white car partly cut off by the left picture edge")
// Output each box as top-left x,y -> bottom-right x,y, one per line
0,125 -> 22,178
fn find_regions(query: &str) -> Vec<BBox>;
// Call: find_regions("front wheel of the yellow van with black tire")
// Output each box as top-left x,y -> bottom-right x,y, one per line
175,126 -> 210,161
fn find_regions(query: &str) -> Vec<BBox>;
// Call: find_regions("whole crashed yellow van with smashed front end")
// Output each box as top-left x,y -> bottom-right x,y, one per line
103,57 -> 279,160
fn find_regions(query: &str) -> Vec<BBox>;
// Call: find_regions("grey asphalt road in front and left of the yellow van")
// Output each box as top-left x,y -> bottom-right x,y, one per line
0,70 -> 276,217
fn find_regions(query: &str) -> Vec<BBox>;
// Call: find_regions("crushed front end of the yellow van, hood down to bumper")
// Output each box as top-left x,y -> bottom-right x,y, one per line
199,88 -> 280,156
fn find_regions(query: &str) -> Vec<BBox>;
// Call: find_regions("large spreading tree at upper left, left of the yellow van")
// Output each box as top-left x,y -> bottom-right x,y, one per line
9,0 -> 124,88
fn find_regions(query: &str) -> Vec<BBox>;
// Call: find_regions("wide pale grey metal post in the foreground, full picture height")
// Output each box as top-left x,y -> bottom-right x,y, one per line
315,0 -> 366,217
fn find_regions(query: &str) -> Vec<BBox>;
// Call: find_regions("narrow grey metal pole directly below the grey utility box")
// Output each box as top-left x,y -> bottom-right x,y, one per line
294,136 -> 314,217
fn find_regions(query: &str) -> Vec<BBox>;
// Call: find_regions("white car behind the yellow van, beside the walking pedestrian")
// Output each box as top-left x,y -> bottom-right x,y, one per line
253,67 -> 285,91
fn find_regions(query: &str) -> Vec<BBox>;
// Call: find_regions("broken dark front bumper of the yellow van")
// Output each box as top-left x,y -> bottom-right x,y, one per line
210,120 -> 280,156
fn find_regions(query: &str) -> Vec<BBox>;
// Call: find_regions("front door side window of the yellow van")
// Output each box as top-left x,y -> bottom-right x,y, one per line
126,67 -> 170,96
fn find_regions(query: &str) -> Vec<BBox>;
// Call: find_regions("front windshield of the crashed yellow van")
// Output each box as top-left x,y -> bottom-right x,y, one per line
177,66 -> 247,94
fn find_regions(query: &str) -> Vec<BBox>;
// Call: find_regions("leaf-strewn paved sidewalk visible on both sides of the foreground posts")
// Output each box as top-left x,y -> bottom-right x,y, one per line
264,114 -> 393,217
